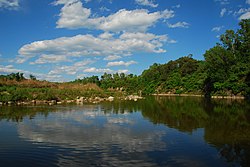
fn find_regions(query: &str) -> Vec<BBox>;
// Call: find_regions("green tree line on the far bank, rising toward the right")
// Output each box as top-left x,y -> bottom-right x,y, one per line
0,19 -> 250,97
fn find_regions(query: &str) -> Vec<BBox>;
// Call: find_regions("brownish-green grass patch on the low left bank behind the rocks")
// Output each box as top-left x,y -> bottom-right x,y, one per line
0,79 -> 115,102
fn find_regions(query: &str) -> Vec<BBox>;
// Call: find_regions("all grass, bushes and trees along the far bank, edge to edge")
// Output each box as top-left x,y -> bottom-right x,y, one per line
0,19 -> 250,102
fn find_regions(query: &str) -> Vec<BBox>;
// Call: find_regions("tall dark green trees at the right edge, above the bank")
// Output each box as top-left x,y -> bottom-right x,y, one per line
204,19 -> 250,96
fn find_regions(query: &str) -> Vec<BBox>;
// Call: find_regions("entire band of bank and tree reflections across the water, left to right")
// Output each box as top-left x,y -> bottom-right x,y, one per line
0,96 -> 250,166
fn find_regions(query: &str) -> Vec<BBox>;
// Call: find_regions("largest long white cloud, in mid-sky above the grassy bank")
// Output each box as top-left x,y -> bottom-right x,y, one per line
16,32 -> 172,64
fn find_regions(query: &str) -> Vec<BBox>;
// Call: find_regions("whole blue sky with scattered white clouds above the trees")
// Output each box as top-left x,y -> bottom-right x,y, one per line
0,0 -> 250,82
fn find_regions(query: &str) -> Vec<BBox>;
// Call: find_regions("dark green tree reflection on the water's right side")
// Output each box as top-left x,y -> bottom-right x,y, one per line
142,97 -> 250,166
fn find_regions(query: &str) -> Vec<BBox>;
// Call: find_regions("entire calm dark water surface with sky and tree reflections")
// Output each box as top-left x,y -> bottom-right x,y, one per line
0,97 -> 250,167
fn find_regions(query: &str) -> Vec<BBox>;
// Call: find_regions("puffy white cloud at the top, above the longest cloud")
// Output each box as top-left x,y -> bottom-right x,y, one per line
54,0 -> 174,32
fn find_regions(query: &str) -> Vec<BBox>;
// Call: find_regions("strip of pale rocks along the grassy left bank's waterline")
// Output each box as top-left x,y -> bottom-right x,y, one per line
0,95 -> 144,106
